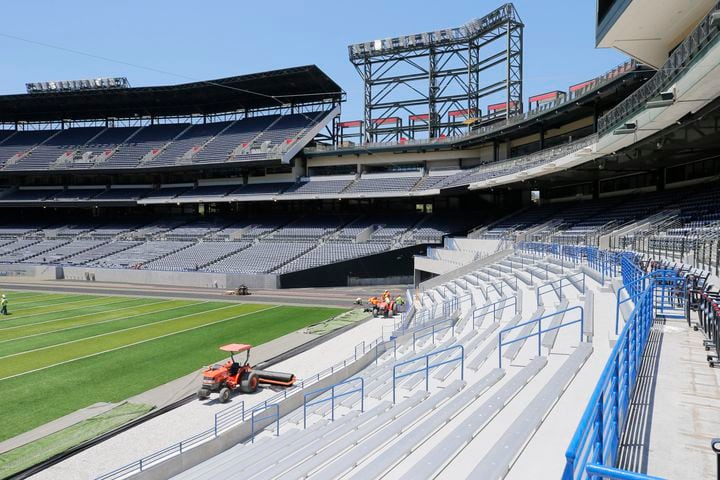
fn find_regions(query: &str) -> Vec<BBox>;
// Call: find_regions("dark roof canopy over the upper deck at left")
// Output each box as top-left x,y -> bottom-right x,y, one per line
0,65 -> 344,122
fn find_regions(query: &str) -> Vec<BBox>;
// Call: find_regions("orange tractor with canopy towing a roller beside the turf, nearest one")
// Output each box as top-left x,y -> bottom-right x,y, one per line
198,343 -> 296,403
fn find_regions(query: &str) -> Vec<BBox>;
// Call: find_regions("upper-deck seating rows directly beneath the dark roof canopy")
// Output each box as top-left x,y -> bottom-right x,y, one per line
0,111 -> 330,171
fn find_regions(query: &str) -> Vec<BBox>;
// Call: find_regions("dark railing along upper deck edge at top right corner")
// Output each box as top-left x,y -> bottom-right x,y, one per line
598,3 -> 720,134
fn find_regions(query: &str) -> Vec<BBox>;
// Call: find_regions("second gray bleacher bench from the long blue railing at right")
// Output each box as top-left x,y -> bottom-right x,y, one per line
400,357 -> 547,480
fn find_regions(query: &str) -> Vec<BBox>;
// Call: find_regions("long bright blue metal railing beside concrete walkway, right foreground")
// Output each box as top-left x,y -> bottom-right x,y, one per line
562,270 -> 679,480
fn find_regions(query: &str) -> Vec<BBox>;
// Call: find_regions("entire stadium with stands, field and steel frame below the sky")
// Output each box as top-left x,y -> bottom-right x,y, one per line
0,0 -> 720,480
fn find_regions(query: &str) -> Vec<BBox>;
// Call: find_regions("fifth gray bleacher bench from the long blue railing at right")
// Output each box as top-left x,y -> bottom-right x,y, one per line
250,392 -> 428,480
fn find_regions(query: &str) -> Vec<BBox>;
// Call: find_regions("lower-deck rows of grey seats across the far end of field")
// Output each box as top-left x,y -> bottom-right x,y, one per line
0,214 -> 473,274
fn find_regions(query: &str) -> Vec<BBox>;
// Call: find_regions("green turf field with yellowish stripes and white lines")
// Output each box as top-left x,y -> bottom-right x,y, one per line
0,291 -> 343,441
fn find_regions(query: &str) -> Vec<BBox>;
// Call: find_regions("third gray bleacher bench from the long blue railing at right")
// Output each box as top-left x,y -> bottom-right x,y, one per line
350,368 -> 505,480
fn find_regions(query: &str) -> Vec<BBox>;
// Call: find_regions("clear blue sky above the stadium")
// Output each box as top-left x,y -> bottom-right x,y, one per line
0,0 -> 625,119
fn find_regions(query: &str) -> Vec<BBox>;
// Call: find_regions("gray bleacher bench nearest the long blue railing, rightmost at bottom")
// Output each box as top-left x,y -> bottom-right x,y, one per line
468,343 -> 593,480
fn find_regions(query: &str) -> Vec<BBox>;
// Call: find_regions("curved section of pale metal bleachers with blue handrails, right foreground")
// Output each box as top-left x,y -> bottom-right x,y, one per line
167,248 -> 603,480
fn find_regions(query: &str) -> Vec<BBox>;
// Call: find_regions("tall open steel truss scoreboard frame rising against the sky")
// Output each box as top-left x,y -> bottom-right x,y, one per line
348,3 -> 524,142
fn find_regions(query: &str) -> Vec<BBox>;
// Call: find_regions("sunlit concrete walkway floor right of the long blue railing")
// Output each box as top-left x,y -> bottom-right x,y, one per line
620,320 -> 720,479
